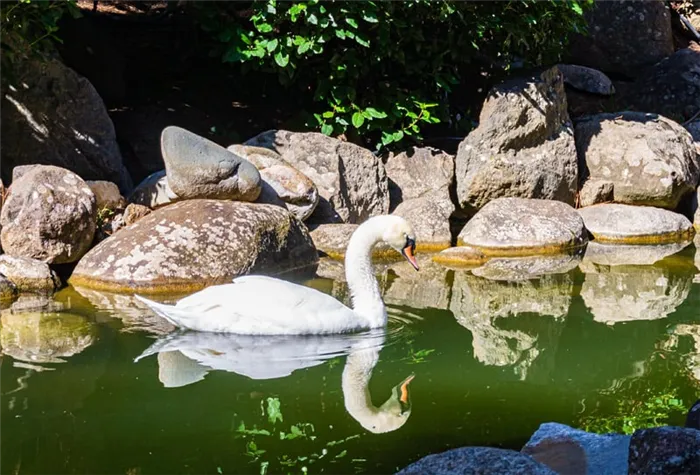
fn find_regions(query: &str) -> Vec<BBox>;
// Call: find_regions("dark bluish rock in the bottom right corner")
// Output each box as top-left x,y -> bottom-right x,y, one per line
629,427 -> 700,475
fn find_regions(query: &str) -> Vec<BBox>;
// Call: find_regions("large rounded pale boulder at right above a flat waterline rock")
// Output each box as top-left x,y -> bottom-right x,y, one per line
576,112 -> 700,209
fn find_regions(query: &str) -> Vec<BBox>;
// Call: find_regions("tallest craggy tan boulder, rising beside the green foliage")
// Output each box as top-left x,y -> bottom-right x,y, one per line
455,68 -> 578,215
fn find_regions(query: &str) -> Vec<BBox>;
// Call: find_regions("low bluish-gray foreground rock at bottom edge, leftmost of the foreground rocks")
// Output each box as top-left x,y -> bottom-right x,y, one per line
397,447 -> 556,475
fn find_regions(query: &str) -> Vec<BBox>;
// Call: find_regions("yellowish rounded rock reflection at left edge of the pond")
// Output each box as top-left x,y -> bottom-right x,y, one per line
0,312 -> 96,363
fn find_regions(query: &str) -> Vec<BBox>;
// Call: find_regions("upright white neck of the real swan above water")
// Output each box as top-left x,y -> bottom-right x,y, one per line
345,218 -> 386,328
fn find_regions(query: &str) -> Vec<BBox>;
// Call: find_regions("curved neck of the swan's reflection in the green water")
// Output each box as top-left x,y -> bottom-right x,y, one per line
343,350 -> 379,425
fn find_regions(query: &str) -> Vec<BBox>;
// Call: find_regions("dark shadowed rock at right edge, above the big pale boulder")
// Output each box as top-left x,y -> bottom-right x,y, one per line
620,44 -> 700,122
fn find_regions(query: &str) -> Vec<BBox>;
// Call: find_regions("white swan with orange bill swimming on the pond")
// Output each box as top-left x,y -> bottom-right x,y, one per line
136,216 -> 418,335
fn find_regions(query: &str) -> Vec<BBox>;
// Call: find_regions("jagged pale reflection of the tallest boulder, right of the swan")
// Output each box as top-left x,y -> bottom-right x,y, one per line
450,271 -> 574,379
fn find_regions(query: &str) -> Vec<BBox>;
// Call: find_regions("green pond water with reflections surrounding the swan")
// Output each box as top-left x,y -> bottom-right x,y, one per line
0,244 -> 700,475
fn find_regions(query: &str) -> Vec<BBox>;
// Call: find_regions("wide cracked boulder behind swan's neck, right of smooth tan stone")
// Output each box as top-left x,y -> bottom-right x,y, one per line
245,130 -> 389,224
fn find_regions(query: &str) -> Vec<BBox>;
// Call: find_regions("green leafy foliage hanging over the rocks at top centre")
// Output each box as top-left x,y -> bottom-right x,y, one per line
194,0 -> 593,146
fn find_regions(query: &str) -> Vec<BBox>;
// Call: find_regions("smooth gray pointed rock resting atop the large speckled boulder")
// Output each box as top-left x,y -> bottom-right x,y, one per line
160,126 -> 260,201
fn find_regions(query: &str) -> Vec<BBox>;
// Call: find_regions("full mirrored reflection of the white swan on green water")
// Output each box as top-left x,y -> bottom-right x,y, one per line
136,329 -> 413,434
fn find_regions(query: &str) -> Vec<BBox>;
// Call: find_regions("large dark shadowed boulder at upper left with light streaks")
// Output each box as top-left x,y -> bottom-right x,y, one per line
0,60 -> 132,192
